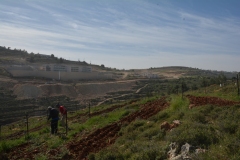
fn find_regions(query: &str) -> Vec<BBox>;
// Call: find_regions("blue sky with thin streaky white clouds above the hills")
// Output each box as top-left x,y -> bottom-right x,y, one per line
0,0 -> 240,72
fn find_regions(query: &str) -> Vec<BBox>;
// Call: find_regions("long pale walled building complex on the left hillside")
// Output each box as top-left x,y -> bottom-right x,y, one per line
5,64 -> 113,80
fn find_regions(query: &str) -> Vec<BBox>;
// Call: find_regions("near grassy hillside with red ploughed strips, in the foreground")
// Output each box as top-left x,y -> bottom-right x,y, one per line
0,78 -> 240,160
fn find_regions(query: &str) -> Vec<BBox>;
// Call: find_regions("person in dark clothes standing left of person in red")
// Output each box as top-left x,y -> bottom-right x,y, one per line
48,106 -> 59,134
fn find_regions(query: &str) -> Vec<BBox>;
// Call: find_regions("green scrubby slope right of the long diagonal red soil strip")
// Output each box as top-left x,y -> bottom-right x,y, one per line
91,85 -> 240,160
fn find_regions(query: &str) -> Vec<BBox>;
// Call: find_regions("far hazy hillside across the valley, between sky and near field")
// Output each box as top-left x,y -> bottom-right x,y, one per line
0,47 -> 236,124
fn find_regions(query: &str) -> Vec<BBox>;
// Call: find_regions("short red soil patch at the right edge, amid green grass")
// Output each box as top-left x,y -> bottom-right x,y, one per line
186,95 -> 240,107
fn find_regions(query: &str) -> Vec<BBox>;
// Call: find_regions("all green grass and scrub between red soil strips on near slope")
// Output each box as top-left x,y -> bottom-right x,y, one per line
0,85 -> 240,160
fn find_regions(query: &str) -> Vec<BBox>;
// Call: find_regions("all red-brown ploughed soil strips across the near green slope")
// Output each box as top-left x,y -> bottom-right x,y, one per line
3,95 -> 240,160
